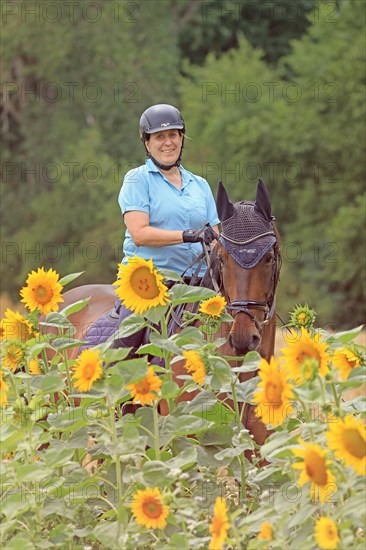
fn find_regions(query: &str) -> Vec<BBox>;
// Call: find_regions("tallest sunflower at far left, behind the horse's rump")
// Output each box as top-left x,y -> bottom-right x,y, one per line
20,267 -> 64,315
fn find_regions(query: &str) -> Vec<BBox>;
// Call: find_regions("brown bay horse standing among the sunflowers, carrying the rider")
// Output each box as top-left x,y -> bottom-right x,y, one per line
57,180 -> 281,445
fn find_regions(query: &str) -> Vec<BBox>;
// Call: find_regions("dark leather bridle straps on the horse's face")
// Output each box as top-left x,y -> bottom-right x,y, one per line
204,227 -> 281,332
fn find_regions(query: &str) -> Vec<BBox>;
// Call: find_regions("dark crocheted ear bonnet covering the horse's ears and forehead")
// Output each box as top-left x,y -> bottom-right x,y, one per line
216,180 -> 276,269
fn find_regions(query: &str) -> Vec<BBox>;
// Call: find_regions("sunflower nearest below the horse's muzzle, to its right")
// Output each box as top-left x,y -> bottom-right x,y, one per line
253,357 -> 294,426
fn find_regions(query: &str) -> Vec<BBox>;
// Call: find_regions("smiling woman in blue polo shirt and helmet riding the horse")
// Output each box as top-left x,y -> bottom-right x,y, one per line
113,104 -> 219,347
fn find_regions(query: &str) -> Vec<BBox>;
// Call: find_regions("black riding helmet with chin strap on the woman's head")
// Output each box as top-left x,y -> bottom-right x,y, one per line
140,103 -> 185,170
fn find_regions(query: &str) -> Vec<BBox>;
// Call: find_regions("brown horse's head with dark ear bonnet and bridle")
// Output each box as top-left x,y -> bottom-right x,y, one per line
208,180 -> 280,355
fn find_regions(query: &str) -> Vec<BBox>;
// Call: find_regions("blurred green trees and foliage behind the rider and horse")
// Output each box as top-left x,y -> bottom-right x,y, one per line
1,0 -> 366,327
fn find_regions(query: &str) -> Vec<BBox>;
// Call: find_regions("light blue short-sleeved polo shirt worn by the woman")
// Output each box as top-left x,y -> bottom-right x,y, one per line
118,159 -> 220,276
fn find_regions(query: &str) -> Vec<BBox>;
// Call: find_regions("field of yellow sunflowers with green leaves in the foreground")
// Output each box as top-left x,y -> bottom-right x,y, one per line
0,259 -> 366,550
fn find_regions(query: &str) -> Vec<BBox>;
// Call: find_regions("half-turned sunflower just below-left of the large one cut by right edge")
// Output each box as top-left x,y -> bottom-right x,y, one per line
292,439 -> 336,502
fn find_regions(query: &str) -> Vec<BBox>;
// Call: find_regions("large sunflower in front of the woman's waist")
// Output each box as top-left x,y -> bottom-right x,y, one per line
113,256 -> 169,313
